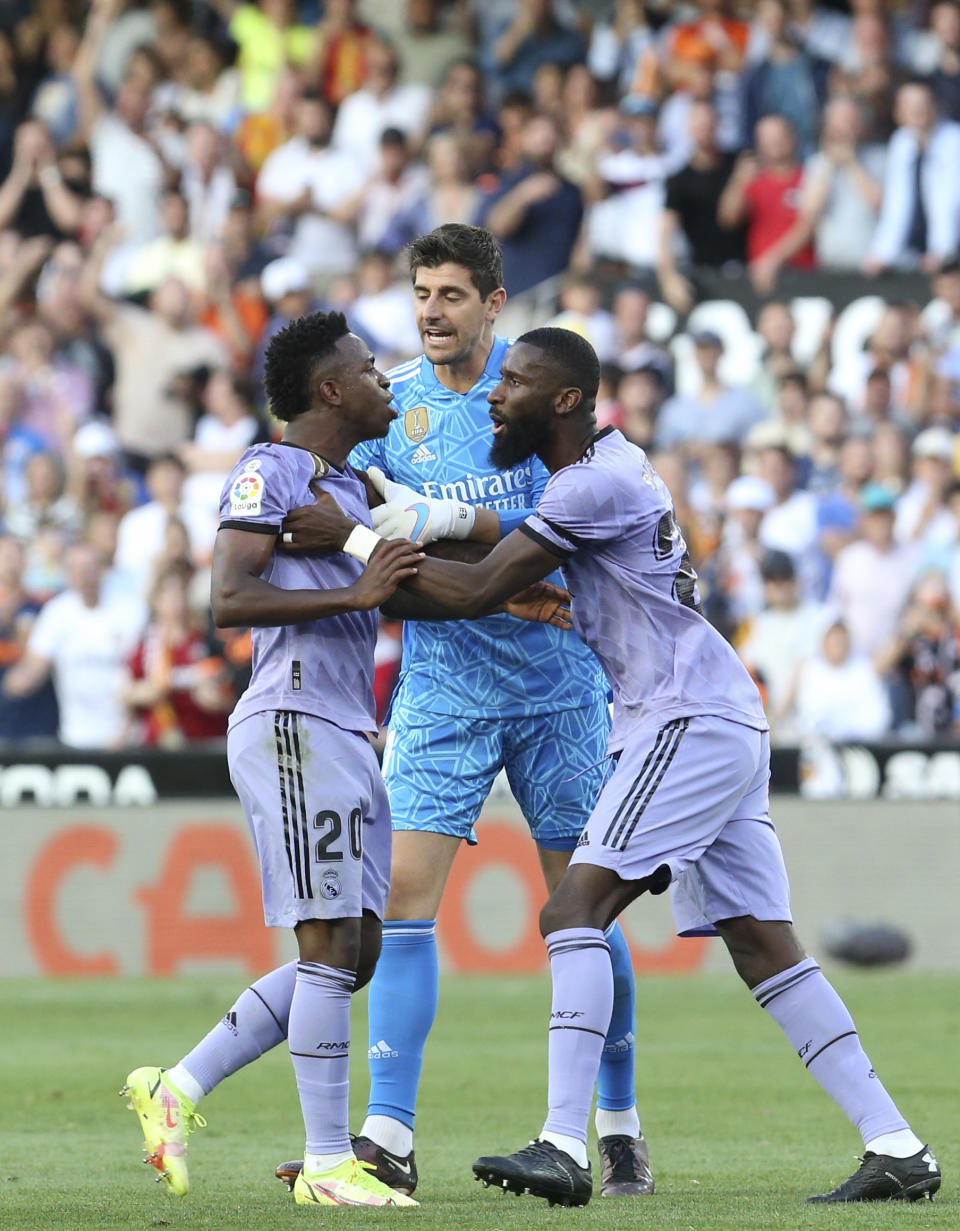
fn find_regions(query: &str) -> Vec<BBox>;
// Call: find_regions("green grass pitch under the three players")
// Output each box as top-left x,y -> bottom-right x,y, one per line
0,972 -> 960,1231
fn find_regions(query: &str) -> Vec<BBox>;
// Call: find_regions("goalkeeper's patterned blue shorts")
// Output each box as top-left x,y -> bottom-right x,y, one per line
383,688 -> 610,851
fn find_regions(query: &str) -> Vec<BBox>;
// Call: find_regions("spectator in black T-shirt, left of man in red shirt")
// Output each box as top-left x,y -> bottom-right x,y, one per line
657,102 -> 746,314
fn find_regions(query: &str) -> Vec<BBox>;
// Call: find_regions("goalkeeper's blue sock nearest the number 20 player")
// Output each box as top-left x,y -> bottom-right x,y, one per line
361,920 -> 439,1132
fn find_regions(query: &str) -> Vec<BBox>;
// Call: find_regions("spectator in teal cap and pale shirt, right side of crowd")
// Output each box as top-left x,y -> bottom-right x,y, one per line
828,484 -> 916,655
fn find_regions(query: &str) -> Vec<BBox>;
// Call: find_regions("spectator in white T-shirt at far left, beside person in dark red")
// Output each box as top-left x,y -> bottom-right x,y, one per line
2,544 -> 146,748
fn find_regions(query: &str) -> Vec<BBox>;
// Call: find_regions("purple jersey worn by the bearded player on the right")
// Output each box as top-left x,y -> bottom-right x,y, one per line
521,428 -> 767,752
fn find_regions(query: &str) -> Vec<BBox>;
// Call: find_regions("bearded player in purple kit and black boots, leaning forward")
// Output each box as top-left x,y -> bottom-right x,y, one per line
311,329 -> 940,1205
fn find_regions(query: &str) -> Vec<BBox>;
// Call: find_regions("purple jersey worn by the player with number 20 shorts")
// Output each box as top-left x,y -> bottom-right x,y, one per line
220,444 -> 378,731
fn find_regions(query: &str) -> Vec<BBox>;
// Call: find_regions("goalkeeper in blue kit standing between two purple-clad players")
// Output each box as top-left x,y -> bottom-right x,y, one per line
278,224 -> 654,1197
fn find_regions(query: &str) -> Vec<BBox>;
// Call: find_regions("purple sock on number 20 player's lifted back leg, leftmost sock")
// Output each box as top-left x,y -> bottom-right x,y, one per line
178,961 -> 297,1094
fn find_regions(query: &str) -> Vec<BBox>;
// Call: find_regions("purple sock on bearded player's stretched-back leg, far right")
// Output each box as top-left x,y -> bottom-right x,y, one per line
752,958 -> 910,1144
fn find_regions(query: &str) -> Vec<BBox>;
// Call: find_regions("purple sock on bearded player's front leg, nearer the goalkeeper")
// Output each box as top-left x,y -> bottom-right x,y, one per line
544,927 -> 613,1141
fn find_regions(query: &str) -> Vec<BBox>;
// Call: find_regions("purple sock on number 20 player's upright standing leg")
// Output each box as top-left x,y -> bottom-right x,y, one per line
287,961 -> 357,1155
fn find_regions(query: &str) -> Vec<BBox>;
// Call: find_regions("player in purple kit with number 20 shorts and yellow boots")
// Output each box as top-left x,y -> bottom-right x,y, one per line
121,313 -> 569,1206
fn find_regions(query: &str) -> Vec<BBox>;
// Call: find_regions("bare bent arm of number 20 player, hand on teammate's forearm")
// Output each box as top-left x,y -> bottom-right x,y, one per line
210,529 -> 421,628
